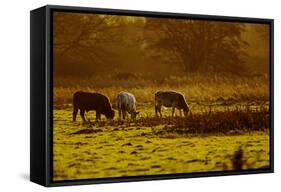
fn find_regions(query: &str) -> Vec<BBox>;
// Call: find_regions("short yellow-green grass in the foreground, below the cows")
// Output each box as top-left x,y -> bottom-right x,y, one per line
54,103 -> 269,181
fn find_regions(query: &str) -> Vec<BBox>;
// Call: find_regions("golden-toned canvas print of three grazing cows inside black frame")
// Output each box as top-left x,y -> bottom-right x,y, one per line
51,11 -> 270,182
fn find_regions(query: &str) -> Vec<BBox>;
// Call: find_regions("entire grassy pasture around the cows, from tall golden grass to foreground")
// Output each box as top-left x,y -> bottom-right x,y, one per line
53,76 -> 270,181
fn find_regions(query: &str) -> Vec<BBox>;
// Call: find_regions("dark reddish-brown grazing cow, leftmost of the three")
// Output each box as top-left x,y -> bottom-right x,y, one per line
72,91 -> 114,122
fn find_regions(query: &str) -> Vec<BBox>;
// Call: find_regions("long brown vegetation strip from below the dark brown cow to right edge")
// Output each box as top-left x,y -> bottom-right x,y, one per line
86,107 -> 270,138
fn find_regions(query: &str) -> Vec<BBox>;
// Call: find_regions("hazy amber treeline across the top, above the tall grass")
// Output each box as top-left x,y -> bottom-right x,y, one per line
53,12 -> 269,76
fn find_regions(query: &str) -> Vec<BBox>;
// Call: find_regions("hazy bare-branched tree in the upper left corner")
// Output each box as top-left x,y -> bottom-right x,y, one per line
53,12 -> 120,75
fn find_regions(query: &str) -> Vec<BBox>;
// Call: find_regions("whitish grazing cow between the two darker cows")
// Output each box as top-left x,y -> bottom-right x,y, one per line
116,92 -> 139,119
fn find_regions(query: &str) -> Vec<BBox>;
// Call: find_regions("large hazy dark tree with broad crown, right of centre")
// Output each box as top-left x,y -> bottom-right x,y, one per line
146,18 -> 246,73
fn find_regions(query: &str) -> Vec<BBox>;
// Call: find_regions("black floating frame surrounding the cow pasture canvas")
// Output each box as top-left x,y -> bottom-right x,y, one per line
30,5 -> 274,186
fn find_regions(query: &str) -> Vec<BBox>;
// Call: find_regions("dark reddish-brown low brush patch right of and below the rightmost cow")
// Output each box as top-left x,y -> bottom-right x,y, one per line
150,108 -> 269,136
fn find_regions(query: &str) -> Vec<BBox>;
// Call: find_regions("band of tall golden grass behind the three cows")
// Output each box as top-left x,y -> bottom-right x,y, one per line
54,75 -> 269,105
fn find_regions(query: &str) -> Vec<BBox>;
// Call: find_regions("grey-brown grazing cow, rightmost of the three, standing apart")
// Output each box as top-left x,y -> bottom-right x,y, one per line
155,91 -> 189,117
